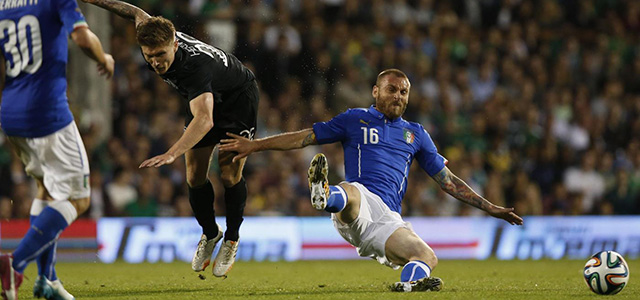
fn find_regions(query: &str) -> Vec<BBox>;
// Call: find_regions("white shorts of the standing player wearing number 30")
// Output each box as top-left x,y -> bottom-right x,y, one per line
8,122 -> 91,200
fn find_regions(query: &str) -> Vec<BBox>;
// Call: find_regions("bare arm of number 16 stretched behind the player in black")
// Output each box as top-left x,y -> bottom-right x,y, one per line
218,128 -> 318,162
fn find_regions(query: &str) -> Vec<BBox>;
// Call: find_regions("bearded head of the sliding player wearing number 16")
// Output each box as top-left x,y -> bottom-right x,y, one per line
372,74 -> 411,119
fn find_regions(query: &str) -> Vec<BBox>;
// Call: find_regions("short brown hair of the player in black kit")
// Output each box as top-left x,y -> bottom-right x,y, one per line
136,17 -> 176,47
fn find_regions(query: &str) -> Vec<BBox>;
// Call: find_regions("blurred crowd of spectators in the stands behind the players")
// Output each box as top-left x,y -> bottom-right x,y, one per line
0,0 -> 640,218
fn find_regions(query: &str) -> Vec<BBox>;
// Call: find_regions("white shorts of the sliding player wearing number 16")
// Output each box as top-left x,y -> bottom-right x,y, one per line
331,182 -> 411,269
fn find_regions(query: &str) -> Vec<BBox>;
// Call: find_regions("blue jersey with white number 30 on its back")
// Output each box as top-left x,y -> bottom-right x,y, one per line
0,0 -> 87,137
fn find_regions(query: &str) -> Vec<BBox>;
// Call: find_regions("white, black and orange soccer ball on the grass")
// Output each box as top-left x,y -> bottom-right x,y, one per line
584,251 -> 629,295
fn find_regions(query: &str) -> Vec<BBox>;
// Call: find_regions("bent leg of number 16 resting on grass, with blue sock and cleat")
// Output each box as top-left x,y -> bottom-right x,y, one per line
385,227 -> 442,292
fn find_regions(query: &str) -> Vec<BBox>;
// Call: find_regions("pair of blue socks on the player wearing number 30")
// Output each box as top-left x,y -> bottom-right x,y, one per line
13,206 -> 73,274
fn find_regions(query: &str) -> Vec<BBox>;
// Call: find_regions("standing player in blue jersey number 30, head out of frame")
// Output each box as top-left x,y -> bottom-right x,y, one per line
0,0 -> 114,300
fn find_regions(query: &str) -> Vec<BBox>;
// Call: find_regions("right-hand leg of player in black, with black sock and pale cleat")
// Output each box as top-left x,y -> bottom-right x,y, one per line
213,152 -> 247,277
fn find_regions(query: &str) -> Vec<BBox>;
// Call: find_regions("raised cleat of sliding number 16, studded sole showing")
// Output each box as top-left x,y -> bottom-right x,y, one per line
308,153 -> 330,210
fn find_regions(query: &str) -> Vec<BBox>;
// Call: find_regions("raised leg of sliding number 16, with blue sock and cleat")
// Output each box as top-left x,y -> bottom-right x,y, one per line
308,153 -> 360,224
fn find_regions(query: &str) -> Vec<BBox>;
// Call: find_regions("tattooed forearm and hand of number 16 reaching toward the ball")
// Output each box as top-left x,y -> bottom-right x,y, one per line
433,167 -> 523,225
